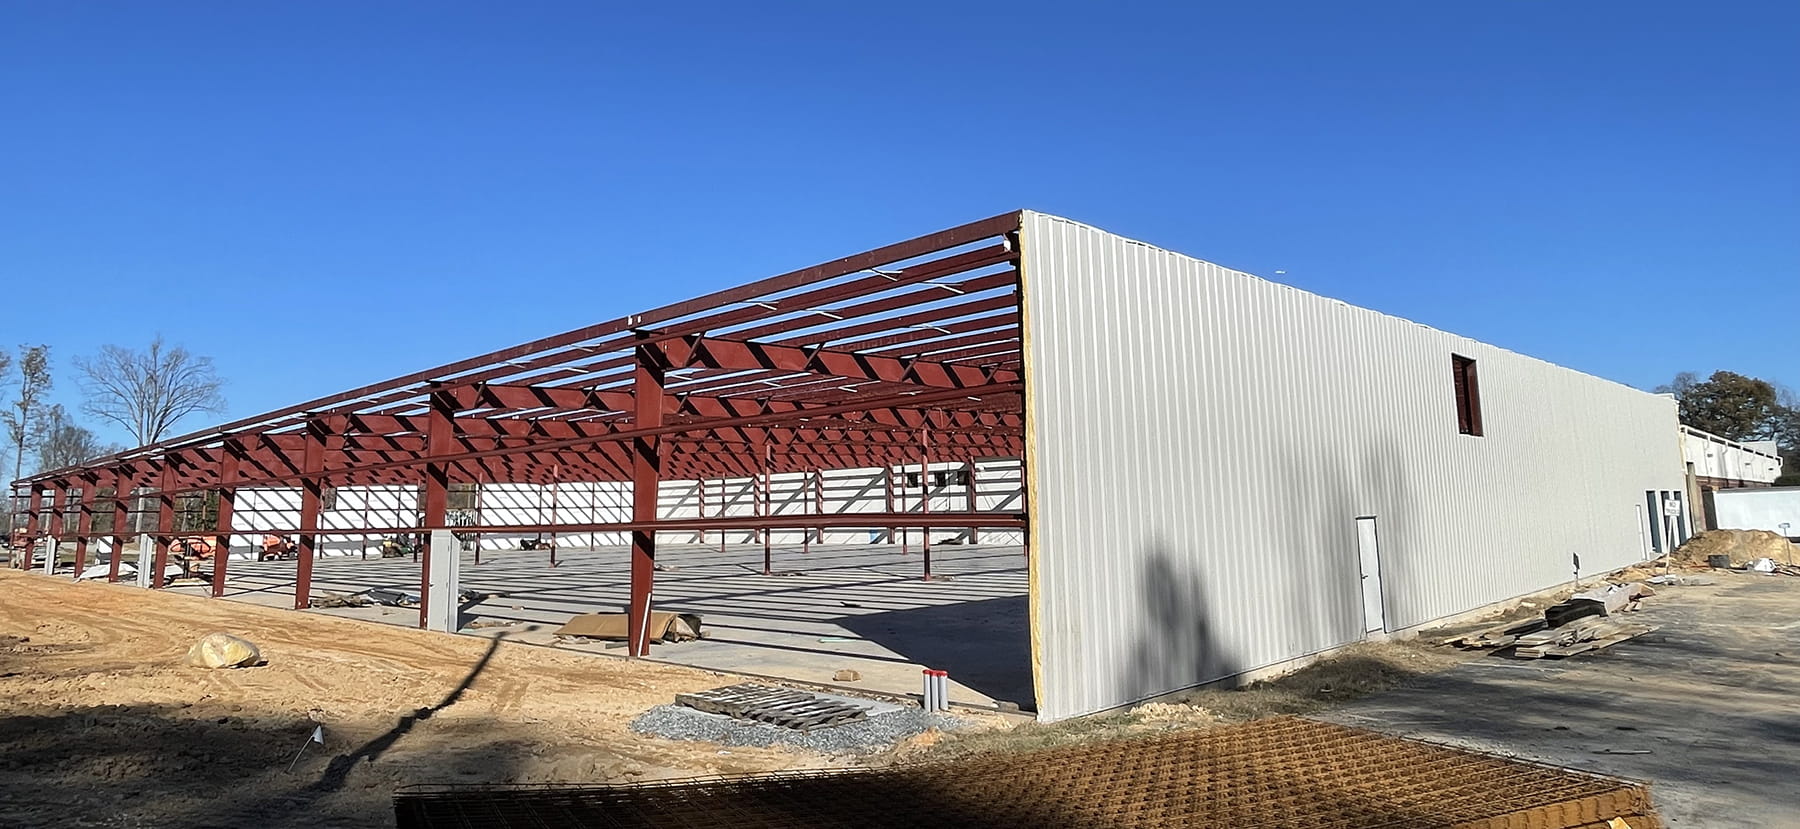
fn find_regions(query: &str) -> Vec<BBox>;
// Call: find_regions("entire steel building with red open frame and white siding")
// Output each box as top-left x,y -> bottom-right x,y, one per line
14,210 -> 1687,719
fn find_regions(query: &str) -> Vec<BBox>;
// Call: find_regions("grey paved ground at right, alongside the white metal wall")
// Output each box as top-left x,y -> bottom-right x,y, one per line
1321,572 -> 1800,829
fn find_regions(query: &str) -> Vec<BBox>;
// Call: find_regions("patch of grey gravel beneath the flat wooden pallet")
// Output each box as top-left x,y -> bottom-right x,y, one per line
632,705 -> 968,753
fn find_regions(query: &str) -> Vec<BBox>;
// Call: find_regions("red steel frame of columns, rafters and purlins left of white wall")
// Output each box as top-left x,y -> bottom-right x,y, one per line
14,212 -> 1024,655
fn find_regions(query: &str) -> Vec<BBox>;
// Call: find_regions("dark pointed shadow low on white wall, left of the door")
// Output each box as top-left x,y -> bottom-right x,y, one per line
1120,541 -> 1242,701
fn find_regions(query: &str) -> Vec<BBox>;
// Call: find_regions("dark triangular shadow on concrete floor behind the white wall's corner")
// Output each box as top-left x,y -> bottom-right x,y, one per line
833,595 -> 1037,710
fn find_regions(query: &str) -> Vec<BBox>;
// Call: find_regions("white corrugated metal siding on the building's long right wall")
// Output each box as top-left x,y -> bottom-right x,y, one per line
1024,212 -> 1683,719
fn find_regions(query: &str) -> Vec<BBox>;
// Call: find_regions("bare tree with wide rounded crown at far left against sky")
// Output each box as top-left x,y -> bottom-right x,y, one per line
76,334 -> 225,446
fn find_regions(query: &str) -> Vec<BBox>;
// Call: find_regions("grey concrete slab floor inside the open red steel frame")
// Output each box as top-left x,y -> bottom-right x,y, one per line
171,545 -> 1033,710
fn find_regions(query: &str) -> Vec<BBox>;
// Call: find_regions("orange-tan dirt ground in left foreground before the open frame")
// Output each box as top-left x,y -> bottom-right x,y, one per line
0,570 -> 832,827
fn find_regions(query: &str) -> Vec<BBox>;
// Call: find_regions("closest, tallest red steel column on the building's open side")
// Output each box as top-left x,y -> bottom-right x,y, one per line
625,343 -> 666,656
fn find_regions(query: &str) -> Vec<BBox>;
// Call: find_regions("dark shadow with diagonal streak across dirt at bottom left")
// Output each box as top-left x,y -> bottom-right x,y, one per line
0,640 -> 527,829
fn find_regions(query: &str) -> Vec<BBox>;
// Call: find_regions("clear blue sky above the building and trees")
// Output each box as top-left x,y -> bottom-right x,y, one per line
0,0 -> 1800,449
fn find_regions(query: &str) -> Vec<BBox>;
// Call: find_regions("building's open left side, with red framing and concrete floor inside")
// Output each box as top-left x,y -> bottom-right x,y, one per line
14,214 -> 1031,709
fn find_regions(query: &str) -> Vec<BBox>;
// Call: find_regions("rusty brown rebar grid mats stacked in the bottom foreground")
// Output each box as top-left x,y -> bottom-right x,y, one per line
394,718 -> 1658,829
